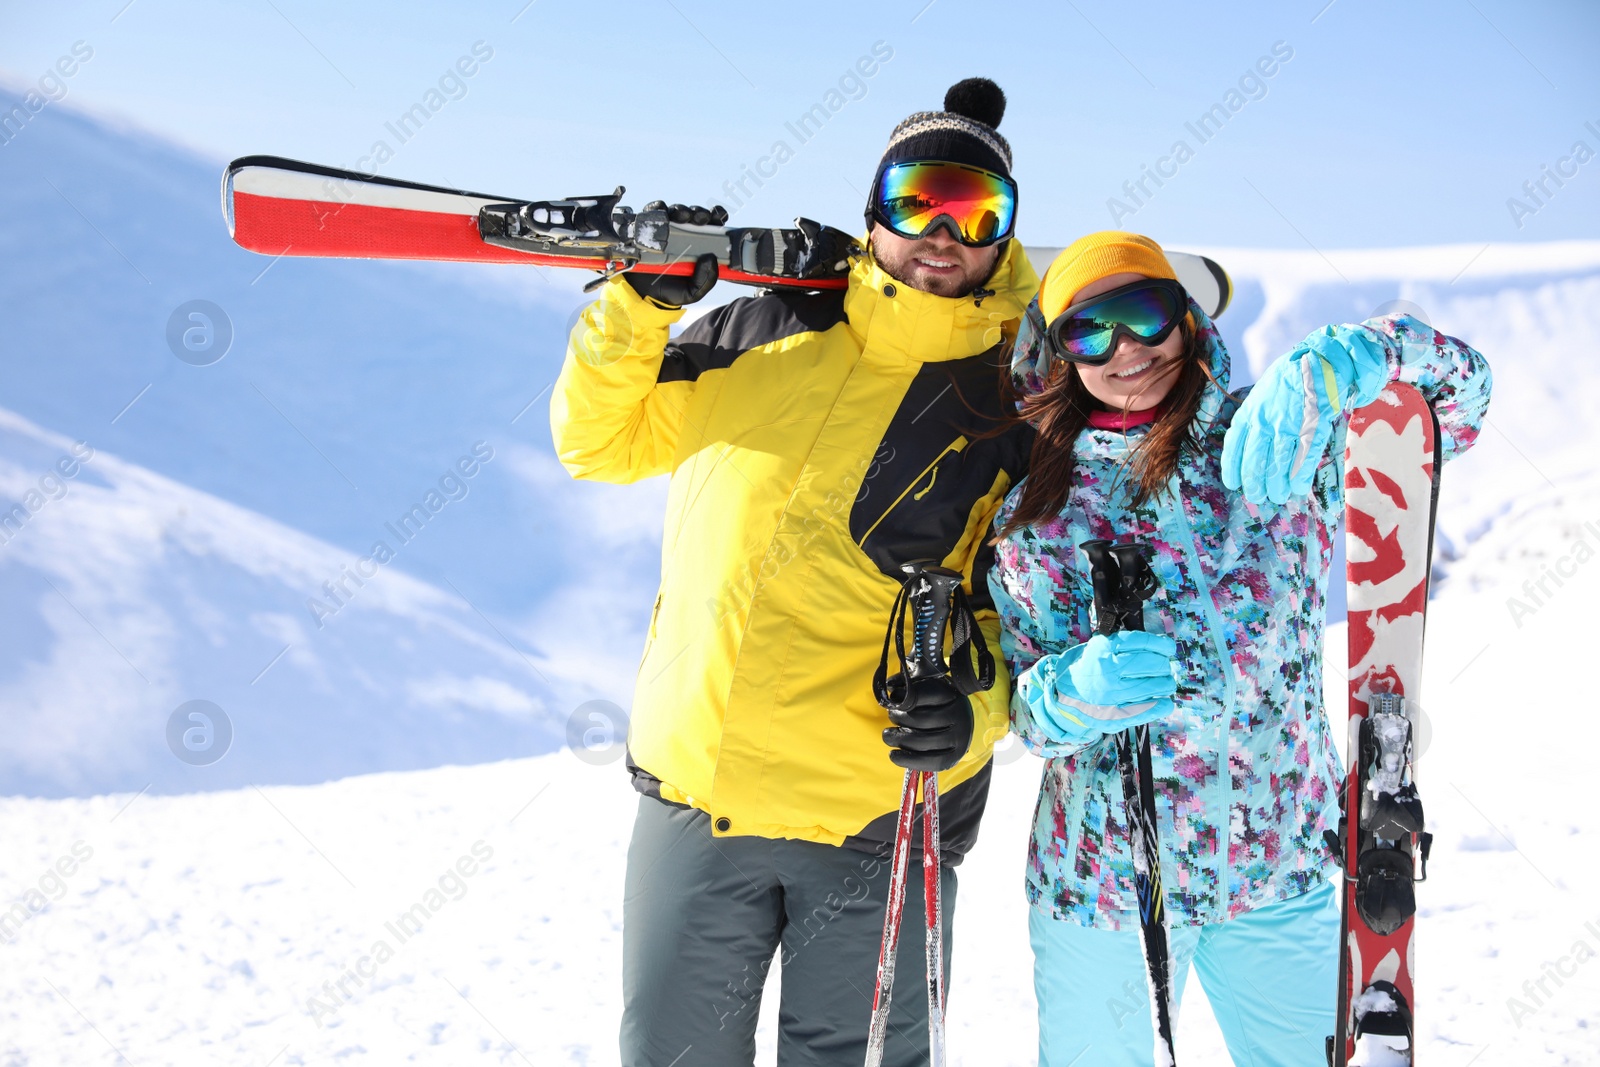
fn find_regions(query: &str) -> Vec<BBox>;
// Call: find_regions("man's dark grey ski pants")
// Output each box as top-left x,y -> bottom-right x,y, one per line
622,797 -> 955,1067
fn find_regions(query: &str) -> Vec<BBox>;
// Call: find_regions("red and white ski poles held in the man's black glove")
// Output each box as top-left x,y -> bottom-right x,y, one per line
866,560 -> 994,1067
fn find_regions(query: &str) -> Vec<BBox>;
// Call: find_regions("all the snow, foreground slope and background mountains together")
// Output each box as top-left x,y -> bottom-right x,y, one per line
0,94 -> 1600,1067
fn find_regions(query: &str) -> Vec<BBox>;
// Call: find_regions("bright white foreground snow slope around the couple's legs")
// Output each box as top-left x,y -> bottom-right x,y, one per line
0,527 -> 1600,1067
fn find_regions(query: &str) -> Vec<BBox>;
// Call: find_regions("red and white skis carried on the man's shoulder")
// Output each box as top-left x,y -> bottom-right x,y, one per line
222,155 -> 1230,317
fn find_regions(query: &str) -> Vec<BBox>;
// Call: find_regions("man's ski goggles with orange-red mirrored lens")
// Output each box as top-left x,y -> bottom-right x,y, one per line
869,160 -> 1016,248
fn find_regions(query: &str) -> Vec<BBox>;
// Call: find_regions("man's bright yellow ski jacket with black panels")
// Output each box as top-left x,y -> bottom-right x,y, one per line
550,242 -> 1038,861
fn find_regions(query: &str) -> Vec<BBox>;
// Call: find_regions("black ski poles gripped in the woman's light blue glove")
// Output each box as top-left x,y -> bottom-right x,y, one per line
1078,539 -> 1176,1067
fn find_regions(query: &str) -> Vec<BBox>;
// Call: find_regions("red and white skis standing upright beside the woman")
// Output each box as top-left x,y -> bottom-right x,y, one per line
1328,382 -> 1438,1067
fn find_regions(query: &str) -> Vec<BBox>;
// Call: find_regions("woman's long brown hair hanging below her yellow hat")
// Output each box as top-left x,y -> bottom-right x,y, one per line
995,322 -> 1221,541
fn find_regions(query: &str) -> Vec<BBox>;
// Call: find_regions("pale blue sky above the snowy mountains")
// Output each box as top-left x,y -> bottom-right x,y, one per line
0,0 -> 1600,248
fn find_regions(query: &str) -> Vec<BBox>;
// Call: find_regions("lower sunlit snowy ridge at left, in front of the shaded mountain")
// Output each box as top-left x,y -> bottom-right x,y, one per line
0,410 -> 576,792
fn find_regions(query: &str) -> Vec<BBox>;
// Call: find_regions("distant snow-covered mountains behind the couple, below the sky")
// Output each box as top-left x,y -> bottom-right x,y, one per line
0,90 -> 1600,797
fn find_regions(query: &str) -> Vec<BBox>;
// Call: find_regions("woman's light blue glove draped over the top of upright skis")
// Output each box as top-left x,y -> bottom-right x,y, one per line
1222,326 -> 1389,504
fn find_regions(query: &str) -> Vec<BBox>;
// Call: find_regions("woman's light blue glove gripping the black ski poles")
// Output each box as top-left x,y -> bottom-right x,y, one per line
1016,630 -> 1178,745
